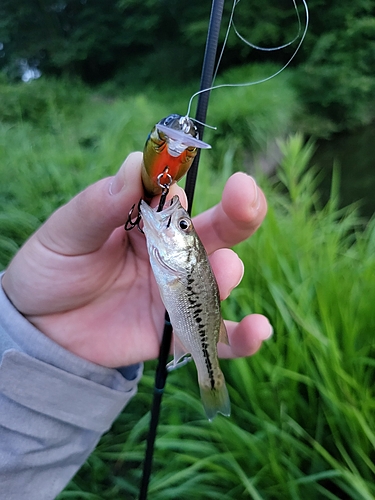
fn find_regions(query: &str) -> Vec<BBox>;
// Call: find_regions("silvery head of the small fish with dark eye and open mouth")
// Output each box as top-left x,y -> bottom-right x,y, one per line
140,195 -> 198,270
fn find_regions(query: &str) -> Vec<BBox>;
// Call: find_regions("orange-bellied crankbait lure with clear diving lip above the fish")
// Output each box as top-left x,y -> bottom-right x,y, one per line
141,114 -> 211,198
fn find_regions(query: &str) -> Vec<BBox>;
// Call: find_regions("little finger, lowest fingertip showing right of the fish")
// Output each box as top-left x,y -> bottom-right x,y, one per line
217,314 -> 273,358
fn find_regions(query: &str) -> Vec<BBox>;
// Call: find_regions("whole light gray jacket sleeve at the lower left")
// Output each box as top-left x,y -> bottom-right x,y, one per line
0,275 -> 142,500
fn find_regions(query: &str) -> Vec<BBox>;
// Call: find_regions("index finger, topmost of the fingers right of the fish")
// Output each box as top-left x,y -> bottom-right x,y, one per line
194,172 -> 267,254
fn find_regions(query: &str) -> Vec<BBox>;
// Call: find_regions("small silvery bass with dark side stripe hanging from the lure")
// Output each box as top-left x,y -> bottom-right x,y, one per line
140,195 -> 231,421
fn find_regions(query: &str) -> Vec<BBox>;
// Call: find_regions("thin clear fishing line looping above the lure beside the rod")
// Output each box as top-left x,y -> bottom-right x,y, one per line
186,0 -> 309,117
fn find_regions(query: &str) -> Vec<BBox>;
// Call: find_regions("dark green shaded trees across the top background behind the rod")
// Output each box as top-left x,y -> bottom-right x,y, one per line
0,0 -> 375,131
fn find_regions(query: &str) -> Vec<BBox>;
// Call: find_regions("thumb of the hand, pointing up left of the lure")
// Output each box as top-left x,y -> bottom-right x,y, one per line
37,152 -> 143,255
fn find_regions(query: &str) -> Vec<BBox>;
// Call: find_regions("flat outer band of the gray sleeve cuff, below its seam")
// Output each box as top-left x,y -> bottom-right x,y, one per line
0,350 -> 142,433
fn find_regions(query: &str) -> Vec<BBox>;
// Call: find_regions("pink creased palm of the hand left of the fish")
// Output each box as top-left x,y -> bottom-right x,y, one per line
11,227 -> 164,367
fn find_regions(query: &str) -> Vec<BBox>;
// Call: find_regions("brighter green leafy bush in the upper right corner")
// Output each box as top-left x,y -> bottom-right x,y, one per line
297,0 -> 375,132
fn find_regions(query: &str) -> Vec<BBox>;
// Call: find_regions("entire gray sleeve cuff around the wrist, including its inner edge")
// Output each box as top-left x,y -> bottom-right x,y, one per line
0,275 -> 143,433
